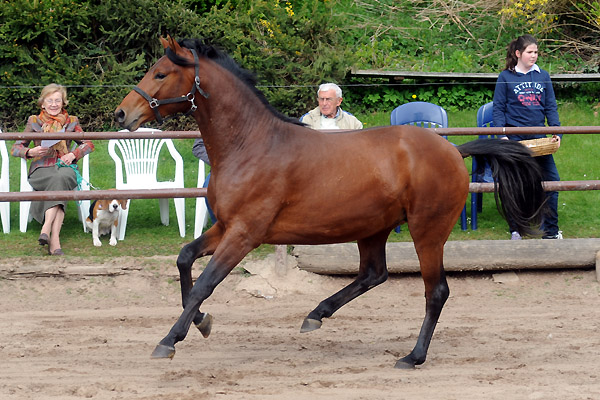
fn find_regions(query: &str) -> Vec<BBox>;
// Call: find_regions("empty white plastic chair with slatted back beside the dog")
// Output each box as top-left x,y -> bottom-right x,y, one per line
108,128 -> 185,240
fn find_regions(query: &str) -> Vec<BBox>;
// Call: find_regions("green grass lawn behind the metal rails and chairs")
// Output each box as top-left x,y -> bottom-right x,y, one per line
0,104 -> 600,260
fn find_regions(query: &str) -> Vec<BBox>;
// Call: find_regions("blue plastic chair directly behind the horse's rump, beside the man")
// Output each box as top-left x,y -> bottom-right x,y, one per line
390,101 -> 467,232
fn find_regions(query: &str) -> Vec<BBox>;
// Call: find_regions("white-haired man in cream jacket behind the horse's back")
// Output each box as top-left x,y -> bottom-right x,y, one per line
300,83 -> 362,129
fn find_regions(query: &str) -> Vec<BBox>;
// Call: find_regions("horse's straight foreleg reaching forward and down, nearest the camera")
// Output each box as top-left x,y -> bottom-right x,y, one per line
152,228 -> 256,358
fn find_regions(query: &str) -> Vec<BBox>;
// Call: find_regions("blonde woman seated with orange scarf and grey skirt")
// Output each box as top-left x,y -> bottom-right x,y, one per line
11,83 -> 94,256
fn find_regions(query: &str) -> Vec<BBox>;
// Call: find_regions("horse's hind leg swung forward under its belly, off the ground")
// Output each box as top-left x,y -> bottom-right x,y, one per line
300,231 -> 389,332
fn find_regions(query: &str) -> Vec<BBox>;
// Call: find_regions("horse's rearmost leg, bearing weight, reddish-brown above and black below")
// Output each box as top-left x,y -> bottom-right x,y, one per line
395,222 -> 453,369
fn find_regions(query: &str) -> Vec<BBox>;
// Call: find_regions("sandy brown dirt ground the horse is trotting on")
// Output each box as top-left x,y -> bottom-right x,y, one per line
0,258 -> 600,400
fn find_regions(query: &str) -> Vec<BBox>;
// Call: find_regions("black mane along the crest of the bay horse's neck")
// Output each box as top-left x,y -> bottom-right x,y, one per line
166,39 -> 305,126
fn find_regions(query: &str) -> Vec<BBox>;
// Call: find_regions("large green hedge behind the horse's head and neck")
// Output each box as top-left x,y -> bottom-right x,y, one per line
0,0 -> 349,131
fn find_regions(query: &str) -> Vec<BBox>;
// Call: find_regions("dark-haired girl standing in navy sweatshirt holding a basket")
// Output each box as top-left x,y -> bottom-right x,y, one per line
494,35 -> 562,240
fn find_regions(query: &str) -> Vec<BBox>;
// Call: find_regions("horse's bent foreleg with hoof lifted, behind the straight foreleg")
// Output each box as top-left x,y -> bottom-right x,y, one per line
177,223 -> 223,337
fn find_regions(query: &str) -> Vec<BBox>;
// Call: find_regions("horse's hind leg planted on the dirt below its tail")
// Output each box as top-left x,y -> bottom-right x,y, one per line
396,242 -> 450,369
